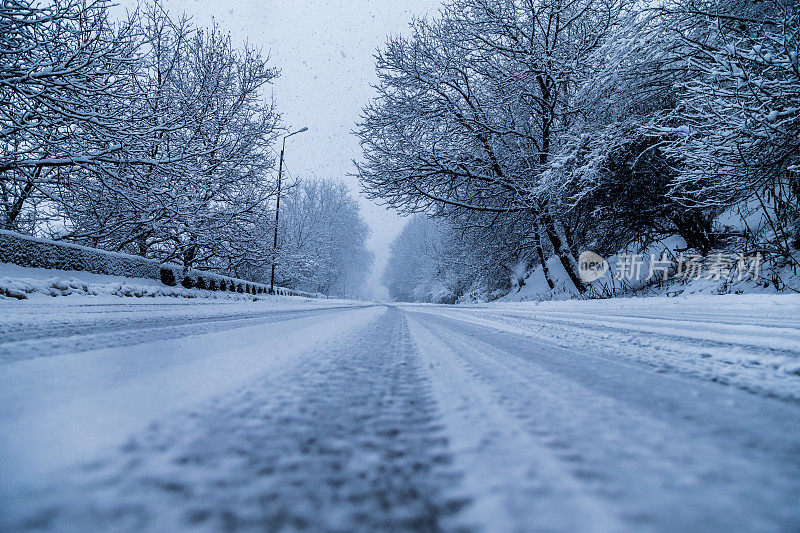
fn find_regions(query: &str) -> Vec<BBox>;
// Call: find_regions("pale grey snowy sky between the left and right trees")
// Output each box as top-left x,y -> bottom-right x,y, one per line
126,0 -> 440,297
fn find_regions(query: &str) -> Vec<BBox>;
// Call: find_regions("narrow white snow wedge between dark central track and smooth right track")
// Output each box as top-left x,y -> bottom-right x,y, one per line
409,319 -> 622,532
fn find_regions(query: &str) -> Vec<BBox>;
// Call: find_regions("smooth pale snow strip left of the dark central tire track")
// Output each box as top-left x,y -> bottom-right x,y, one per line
0,307 -> 382,489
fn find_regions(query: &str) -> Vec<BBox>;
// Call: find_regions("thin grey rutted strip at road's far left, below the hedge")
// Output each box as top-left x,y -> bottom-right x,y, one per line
0,302 -> 364,364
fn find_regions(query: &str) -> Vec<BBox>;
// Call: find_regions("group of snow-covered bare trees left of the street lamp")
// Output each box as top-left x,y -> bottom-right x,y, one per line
0,0 -> 372,296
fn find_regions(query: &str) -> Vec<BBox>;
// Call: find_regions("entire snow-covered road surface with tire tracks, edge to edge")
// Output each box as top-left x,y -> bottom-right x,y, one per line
0,302 -> 800,531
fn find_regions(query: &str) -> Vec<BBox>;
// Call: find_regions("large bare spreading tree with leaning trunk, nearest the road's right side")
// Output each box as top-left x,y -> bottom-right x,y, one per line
359,0 -> 636,290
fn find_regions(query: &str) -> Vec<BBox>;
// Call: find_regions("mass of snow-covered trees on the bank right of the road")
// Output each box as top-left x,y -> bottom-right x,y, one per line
358,0 -> 800,300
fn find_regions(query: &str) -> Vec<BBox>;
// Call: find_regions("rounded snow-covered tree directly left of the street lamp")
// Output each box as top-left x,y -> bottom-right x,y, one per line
56,3 -> 278,267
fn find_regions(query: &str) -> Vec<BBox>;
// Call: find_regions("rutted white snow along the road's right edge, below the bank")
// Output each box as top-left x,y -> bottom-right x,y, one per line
409,294 -> 800,400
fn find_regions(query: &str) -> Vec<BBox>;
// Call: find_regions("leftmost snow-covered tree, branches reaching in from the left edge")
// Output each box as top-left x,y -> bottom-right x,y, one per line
0,0 -> 138,229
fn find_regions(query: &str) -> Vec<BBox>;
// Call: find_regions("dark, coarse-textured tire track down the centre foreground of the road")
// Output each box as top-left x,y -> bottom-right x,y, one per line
4,309 -> 467,531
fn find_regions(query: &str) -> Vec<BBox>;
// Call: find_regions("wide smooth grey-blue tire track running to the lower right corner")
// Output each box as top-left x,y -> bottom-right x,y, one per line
406,313 -> 800,530
